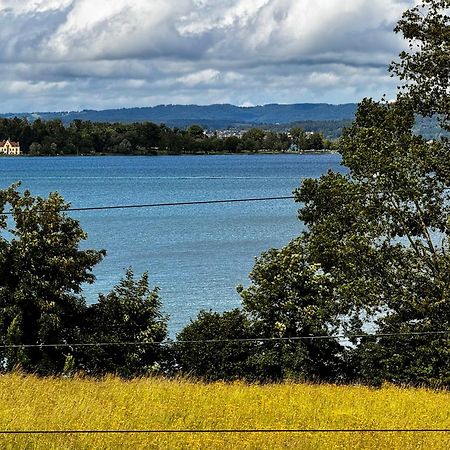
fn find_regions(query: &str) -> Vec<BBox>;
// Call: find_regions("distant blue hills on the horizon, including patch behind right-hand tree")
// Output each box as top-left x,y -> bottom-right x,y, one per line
0,103 -> 448,139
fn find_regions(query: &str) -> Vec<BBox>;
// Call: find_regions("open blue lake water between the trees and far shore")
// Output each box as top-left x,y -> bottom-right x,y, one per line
0,155 -> 342,334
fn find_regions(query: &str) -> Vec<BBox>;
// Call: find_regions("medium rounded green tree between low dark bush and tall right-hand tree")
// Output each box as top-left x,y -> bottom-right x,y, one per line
238,238 -> 345,381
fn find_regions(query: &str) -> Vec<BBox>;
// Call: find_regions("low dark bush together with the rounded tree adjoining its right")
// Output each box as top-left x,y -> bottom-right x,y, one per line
175,239 -> 346,382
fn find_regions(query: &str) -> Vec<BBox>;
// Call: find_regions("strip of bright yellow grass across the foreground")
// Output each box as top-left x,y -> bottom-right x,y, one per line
0,374 -> 450,449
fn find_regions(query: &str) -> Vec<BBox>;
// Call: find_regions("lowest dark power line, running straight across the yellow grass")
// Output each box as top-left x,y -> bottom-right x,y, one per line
0,428 -> 450,434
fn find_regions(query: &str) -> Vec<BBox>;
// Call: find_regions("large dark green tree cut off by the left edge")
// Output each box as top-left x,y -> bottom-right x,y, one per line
0,185 -> 105,374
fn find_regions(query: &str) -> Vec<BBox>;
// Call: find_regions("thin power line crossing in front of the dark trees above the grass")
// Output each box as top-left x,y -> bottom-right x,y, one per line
0,330 -> 450,349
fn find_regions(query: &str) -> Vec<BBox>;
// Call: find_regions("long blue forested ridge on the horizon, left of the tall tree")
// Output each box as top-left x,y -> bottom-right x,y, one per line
0,103 -> 357,129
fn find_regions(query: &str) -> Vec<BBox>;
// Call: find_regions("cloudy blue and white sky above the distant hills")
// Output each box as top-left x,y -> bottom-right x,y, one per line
0,0 -> 414,113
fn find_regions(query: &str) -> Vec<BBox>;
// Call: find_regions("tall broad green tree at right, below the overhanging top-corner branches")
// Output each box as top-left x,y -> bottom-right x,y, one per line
296,97 -> 450,382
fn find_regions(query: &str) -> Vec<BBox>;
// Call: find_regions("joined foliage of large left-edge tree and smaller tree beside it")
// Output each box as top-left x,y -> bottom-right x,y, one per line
0,186 -> 167,376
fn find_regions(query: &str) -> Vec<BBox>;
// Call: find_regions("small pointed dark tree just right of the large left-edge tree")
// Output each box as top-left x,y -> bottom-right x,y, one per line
82,269 -> 168,377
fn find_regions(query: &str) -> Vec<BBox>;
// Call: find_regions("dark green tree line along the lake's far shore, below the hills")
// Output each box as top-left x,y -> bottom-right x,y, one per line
0,117 -> 331,155
